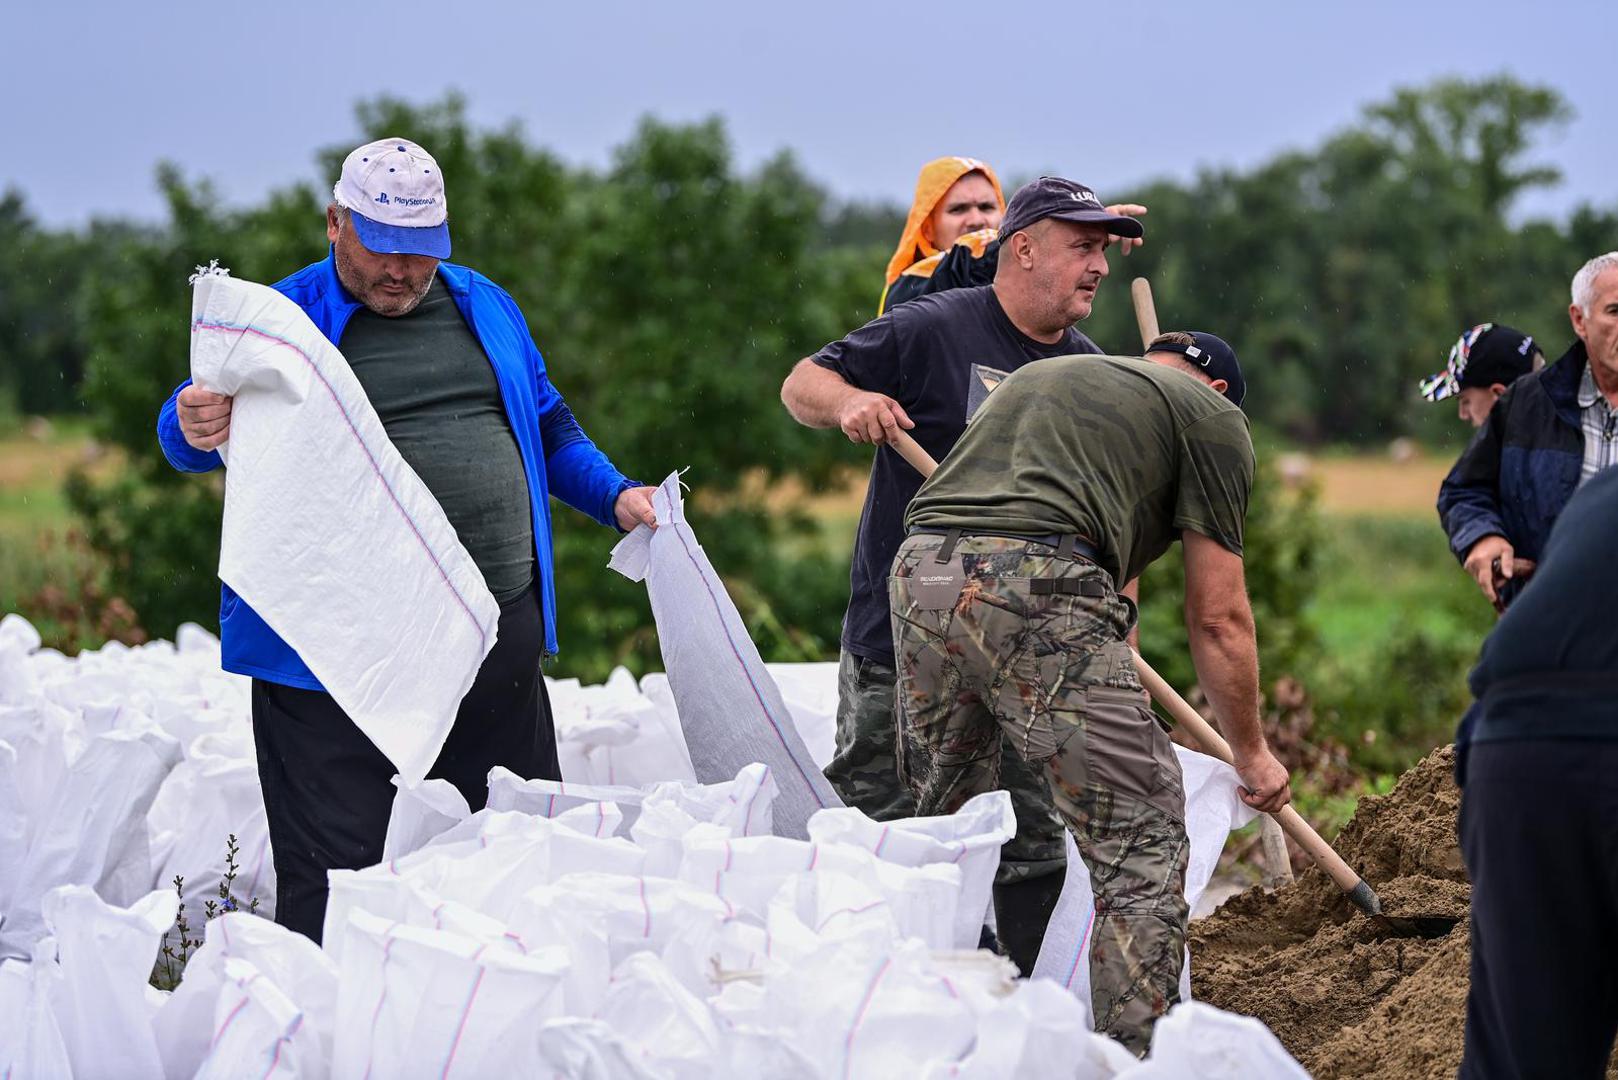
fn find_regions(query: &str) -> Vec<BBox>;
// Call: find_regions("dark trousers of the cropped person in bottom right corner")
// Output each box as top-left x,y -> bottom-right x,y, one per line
1459,742 -> 1618,1080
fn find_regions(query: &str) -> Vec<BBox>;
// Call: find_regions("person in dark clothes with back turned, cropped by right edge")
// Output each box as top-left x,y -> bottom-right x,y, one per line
1456,463 -> 1618,1080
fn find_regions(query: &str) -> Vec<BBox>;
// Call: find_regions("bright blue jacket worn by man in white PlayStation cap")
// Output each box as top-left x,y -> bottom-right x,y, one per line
157,254 -> 636,690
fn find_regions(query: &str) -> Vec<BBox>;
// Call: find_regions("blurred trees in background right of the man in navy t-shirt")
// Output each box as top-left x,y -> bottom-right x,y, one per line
1074,78 -> 1618,444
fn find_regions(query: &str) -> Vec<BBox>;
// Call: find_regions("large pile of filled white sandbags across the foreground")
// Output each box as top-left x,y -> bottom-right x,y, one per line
0,615 -> 1302,1080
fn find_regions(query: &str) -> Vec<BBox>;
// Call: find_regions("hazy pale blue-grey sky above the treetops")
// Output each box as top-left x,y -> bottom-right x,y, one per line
0,0 -> 1618,223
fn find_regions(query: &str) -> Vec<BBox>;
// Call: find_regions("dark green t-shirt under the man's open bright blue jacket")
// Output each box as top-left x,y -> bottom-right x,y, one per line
338,277 -> 534,604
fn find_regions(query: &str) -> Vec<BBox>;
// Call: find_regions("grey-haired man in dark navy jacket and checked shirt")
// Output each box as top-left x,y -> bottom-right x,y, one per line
1438,251 -> 1618,610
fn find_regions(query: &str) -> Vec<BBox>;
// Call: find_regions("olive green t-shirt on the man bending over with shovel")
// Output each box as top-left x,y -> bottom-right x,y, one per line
904,356 -> 1254,585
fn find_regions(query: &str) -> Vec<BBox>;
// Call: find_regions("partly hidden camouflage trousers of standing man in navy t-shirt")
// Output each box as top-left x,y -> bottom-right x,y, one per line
825,651 -> 1068,884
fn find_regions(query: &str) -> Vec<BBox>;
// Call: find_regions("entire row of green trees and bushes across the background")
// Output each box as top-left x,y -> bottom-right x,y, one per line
0,79 -> 1618,702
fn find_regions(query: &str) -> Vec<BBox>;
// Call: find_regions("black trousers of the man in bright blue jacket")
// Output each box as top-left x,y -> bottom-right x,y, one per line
252,586 -> 561,942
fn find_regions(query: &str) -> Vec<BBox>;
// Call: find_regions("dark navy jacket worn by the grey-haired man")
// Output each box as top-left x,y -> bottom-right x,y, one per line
1438,342 -> 1589,595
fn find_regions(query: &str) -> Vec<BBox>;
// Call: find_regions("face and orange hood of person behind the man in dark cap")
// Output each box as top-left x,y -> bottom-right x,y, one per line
877,157 -> 1006,314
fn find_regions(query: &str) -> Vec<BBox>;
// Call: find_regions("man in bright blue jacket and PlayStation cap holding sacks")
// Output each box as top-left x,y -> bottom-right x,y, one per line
157,139 -> 655,941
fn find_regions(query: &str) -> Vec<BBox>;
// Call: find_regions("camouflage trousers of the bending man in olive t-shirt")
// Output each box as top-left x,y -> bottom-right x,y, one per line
888,534 -> 1188,1054
